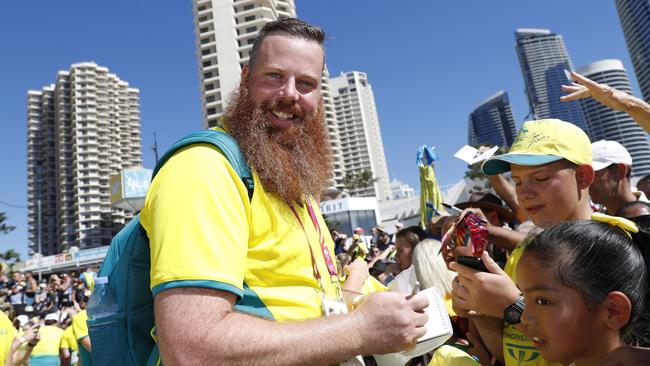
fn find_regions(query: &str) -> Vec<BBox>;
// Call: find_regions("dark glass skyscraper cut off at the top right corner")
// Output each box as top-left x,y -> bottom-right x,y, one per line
616,0 -> 650,101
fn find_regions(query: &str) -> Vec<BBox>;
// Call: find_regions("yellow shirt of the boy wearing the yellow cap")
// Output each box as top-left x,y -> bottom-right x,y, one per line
503,243 -> 561,366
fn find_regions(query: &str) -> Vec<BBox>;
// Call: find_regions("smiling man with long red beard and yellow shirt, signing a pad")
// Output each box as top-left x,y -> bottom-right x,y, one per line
141,19 -> 428,366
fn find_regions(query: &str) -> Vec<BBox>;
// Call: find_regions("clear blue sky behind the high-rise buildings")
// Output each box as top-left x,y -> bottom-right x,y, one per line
0,0 -> 639,253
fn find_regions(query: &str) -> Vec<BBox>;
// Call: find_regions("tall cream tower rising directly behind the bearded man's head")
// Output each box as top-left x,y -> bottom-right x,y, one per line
193,0 -> 343,189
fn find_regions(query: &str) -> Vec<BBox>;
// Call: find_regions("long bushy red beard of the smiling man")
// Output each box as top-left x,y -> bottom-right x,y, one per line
224,83 -> 332,203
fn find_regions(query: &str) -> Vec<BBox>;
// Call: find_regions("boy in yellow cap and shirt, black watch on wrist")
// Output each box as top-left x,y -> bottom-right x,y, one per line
452,119 -> 594,366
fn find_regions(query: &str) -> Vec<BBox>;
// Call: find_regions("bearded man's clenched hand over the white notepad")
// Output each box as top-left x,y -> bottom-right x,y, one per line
353,291 -> 429,354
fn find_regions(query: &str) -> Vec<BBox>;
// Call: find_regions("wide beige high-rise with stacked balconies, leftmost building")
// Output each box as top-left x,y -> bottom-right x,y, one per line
27,62 -> 142,255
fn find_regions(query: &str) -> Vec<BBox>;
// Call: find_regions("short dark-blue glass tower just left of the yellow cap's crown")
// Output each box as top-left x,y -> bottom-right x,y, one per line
467,90 -> 517,147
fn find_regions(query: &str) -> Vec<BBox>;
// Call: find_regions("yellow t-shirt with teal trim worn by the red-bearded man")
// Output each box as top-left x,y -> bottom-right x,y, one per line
140,144 -> 336,321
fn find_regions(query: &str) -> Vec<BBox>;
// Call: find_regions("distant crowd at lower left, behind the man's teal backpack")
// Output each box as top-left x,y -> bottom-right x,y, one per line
0,267 -> 97,365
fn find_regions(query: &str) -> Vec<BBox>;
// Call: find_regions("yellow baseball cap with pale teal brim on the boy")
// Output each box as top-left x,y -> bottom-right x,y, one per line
481,119 -> 591,175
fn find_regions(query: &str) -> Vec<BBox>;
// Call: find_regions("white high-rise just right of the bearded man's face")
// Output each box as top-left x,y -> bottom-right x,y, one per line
330,71 -> 391,201
